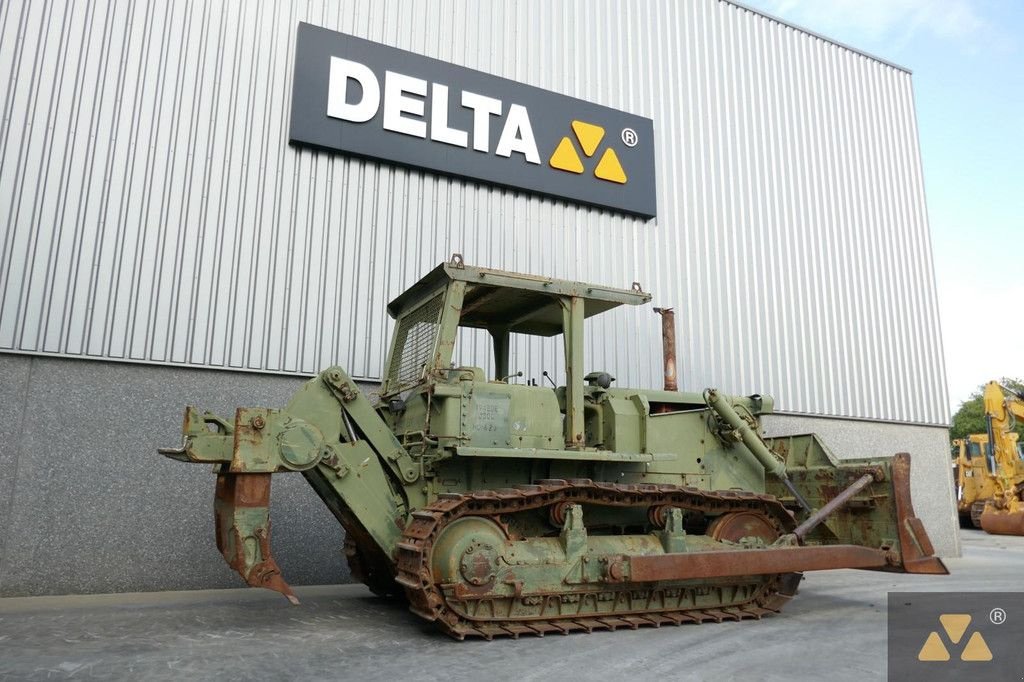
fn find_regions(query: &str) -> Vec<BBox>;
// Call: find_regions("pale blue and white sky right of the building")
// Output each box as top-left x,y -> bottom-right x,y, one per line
741,0 -> 1024,413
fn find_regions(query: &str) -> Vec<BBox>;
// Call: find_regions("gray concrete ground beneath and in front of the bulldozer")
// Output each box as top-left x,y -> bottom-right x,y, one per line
0,530 -> 1024,682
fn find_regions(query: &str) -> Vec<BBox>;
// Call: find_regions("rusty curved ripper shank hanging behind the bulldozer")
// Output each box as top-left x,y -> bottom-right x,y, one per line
214,473 -> 299,604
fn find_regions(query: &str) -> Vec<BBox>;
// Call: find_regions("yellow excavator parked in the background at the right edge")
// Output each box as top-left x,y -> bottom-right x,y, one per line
953,381 -> 1024,536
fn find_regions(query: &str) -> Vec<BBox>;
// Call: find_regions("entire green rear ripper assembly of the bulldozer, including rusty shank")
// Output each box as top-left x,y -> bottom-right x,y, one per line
160,367 -> 411,603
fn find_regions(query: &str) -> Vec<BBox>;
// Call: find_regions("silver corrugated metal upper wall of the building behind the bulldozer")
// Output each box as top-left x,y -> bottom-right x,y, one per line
0,0 -> 948,423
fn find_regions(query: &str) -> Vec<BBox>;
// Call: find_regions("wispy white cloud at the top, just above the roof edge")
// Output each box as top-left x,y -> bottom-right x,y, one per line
750,0 -> 993,50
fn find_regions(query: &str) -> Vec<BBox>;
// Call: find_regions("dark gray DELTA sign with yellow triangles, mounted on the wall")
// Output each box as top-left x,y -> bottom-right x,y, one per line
290,24 -> 656,217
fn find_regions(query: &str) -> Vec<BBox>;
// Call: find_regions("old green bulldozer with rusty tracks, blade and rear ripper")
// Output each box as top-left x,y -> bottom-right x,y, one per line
161,254 -> 947,639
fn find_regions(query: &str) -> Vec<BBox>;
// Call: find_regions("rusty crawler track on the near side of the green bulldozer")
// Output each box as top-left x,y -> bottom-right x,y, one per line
395,479 -> 801,639
